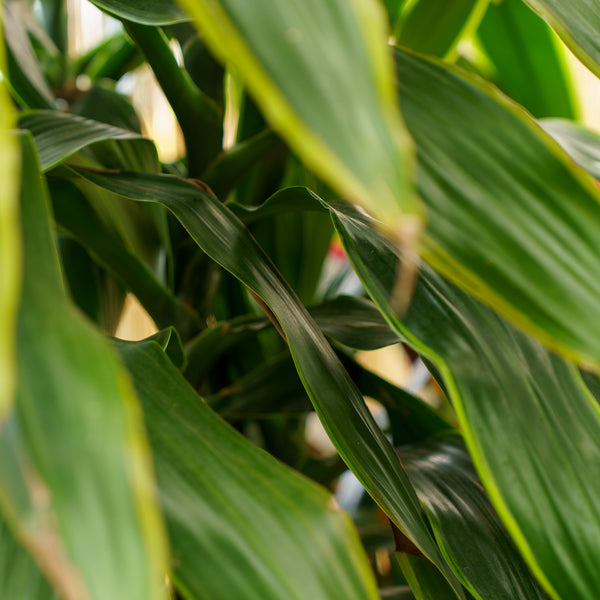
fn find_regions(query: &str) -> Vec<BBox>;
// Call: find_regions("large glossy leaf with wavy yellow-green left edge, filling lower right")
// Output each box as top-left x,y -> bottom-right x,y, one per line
332,198 -> 600,600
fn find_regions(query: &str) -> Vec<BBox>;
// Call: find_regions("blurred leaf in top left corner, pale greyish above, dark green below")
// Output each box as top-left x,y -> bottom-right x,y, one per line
3,0 -> 54,108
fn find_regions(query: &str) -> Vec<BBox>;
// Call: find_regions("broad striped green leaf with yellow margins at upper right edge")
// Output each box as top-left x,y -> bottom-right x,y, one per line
396,51 -> 600,365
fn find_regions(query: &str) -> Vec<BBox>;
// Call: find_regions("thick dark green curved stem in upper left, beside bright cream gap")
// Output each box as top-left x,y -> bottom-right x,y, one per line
123,21 -> 223,177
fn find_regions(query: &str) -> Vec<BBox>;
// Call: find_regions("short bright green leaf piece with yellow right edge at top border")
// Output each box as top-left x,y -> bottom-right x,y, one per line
396,0 -> 489,57
